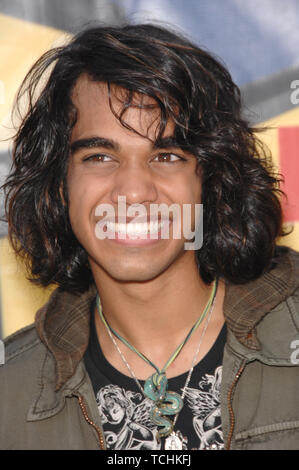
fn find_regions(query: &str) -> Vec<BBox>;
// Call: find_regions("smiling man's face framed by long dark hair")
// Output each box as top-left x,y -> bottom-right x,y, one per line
68,76 -> 201,281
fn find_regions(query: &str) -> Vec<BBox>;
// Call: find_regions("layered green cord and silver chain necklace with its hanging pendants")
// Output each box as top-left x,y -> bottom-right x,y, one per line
96,280 -> 218,449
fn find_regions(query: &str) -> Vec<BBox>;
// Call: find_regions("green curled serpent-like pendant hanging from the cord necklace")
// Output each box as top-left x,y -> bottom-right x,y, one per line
144,372 -> 183,441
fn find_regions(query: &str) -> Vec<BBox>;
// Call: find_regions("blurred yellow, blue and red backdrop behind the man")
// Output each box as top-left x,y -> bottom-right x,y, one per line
0,0 -> 299,338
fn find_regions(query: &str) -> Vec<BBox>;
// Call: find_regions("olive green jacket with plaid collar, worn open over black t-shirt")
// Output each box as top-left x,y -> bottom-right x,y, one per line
0,248 -> 299,450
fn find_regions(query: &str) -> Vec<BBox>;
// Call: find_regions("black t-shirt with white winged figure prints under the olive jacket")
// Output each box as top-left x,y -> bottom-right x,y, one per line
84,304 -> 226,450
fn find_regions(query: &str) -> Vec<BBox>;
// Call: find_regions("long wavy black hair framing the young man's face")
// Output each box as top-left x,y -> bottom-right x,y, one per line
4,24 -> 283,293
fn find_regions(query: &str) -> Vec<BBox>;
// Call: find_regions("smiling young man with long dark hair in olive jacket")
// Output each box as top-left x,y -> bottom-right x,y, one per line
0,25 -> 299,450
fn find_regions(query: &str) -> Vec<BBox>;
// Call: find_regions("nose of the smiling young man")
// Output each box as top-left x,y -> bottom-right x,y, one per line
111,163 -> 158,205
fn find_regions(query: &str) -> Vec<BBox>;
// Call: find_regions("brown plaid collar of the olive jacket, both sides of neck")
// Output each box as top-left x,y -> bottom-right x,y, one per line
35,247 -> 299,390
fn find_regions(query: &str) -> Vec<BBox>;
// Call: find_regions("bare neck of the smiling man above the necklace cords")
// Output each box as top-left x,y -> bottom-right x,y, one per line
95,255 -> 224,353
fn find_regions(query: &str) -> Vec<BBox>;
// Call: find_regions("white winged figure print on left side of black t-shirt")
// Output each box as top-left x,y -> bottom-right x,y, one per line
96,385 -> 161,450
